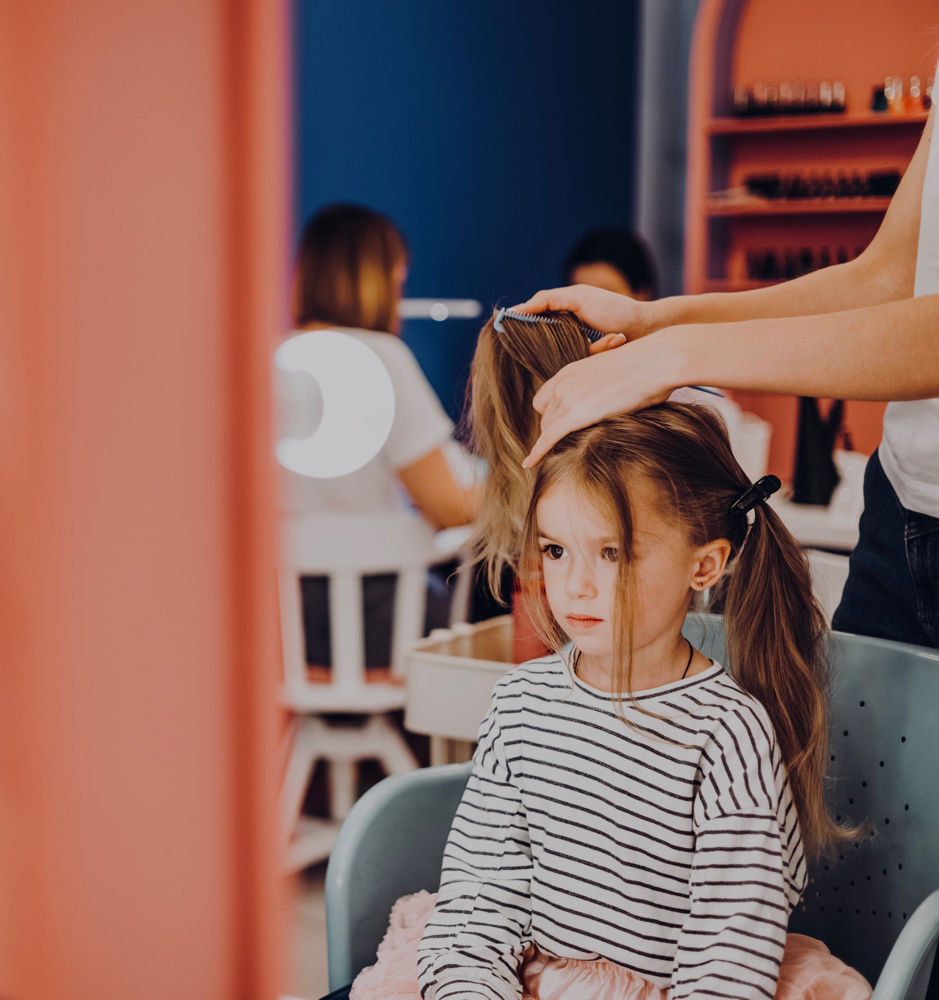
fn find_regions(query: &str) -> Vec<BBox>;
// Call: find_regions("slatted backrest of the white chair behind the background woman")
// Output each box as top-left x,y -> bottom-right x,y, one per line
279,512 -> 441,710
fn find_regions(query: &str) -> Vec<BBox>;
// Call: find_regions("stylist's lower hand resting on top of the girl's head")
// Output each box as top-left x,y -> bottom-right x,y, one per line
522,331 -> 683,469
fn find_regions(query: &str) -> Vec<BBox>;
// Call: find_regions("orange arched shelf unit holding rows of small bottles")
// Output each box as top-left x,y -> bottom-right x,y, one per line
685,0 -> 939,480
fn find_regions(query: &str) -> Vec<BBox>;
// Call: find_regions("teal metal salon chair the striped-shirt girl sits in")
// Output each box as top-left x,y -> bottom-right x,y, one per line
326,615 -> 939,1000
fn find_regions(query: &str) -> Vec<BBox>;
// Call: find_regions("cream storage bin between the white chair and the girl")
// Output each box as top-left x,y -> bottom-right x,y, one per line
404,615 -> 515,740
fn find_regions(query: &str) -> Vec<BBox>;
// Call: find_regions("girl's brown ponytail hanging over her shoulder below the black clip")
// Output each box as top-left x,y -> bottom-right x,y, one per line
722,503 -> 851,855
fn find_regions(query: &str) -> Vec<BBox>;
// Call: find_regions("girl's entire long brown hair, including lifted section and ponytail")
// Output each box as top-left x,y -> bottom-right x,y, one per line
471,312 -> 857,854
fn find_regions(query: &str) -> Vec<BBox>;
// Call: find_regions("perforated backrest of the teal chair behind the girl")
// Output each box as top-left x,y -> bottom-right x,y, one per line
685,616 -> 939,983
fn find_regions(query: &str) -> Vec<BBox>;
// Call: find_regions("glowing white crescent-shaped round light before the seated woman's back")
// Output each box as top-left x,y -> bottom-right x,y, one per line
274,330 -> 395,479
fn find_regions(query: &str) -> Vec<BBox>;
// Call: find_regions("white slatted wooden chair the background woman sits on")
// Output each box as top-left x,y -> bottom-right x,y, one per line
279,512 -> 468,871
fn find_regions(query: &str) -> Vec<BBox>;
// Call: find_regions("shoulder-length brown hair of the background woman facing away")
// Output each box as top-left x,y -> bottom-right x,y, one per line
294,204 -> 408,333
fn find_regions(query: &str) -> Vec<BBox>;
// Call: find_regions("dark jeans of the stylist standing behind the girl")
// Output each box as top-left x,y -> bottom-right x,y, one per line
832,452 -> 939,648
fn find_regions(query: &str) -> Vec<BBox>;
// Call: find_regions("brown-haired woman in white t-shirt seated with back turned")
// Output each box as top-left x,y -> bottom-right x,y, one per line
282,204 -> 478,667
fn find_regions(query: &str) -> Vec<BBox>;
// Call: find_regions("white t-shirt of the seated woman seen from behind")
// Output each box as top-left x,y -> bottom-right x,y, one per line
279,329 -> 453,514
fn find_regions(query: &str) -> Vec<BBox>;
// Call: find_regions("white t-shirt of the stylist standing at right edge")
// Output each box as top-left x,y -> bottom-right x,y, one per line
879,98 -> 939,517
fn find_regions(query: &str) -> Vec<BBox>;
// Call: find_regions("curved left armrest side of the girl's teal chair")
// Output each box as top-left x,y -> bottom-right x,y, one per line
326,762 -> 473,990
